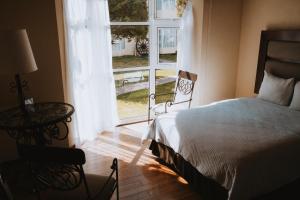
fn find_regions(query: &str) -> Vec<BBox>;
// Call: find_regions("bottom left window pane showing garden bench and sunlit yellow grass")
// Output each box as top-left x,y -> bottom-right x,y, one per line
114,70 -> 149,119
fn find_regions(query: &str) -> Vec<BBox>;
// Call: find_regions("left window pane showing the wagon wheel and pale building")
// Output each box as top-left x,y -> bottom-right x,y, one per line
111,26 -> 149,69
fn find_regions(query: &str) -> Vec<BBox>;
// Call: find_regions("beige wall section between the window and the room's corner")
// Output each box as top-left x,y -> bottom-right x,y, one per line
193,0 -> 242,105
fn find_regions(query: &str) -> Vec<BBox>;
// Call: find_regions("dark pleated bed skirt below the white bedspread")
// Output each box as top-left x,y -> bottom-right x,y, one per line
149,140 -> 300,200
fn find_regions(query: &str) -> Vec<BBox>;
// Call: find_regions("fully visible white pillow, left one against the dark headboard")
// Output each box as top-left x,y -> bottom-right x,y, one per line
257,71 -> 294,106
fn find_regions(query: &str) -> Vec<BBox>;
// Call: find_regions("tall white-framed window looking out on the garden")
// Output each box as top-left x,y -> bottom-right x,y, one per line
108,0 -> 179,123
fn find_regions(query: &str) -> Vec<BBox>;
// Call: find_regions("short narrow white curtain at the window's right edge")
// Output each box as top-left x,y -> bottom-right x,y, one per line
177,0 -> 194,71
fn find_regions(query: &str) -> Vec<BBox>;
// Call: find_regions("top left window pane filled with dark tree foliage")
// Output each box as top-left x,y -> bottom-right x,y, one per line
108,0 -> 148,22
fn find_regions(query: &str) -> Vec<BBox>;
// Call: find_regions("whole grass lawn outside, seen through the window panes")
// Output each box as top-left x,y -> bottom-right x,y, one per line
113,54 -> 177,119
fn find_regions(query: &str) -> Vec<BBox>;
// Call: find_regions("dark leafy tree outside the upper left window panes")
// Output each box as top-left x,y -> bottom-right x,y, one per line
108,0 -> 148,41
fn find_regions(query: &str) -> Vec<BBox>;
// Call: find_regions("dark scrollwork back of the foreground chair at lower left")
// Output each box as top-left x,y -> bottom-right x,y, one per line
18,144 -> 89,196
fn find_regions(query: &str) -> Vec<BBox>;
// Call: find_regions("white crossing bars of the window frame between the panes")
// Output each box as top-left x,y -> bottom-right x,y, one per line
110,0 -> 180,120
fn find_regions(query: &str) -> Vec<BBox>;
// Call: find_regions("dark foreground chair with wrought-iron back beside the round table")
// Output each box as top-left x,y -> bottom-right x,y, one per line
18,145 -> 119,200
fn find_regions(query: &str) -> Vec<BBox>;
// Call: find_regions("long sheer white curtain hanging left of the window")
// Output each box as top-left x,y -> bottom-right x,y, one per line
64,0 -> 117,144
